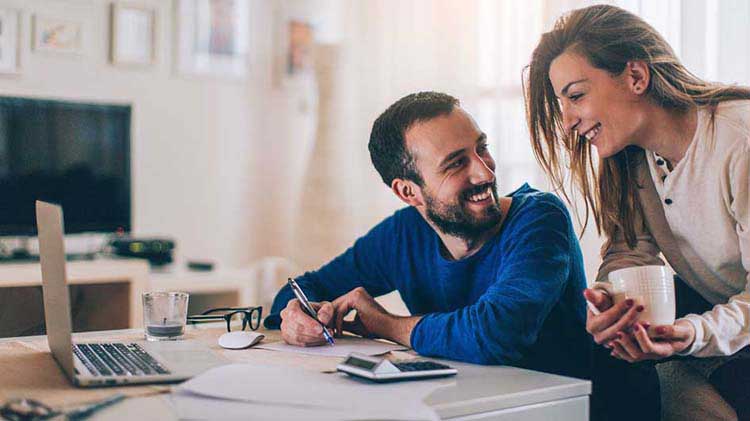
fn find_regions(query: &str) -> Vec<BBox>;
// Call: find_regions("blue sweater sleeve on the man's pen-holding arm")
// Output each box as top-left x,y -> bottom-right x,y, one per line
264,213 -> 400,329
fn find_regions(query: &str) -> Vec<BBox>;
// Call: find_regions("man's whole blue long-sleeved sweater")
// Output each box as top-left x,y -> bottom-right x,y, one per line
265,184 -> 590,377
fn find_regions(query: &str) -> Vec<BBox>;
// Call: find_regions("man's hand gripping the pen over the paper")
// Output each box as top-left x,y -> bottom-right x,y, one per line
280,298 -> 334,346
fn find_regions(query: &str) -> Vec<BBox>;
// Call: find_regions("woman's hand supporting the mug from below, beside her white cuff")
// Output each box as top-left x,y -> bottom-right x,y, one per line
609,320 -> 695,363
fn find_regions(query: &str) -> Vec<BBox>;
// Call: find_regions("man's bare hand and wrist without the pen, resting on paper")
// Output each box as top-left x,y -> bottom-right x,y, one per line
333,287 -> 421,347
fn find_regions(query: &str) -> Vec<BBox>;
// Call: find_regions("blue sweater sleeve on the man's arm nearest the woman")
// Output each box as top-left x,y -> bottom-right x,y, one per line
411,197 -> 575,364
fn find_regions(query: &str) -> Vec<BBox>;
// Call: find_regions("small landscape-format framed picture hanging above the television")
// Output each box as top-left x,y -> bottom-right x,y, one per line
33,15 -> 83,54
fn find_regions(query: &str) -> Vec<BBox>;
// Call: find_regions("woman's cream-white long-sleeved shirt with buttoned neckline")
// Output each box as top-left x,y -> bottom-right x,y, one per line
646,101 -> 750,357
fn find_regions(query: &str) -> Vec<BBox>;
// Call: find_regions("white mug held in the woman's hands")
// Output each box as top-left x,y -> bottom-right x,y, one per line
592,266 -> 675,333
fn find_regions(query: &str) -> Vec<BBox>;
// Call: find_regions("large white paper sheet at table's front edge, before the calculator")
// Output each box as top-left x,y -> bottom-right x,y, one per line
173,364 -> 446,420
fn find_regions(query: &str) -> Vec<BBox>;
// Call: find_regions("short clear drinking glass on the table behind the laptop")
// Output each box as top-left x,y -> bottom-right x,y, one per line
143,292 -> 188,341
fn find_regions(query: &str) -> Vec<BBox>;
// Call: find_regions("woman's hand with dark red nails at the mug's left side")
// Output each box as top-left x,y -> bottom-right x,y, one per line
583,288 -> 643,347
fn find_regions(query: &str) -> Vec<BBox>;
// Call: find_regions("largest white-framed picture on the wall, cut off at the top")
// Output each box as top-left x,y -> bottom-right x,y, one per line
175,0 -> 250,78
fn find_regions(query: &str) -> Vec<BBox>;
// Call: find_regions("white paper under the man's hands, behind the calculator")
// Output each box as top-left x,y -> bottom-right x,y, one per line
255,336 -> 409,357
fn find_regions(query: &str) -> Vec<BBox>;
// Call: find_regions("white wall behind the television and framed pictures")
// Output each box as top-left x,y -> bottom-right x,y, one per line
0,0 -> 280,265
